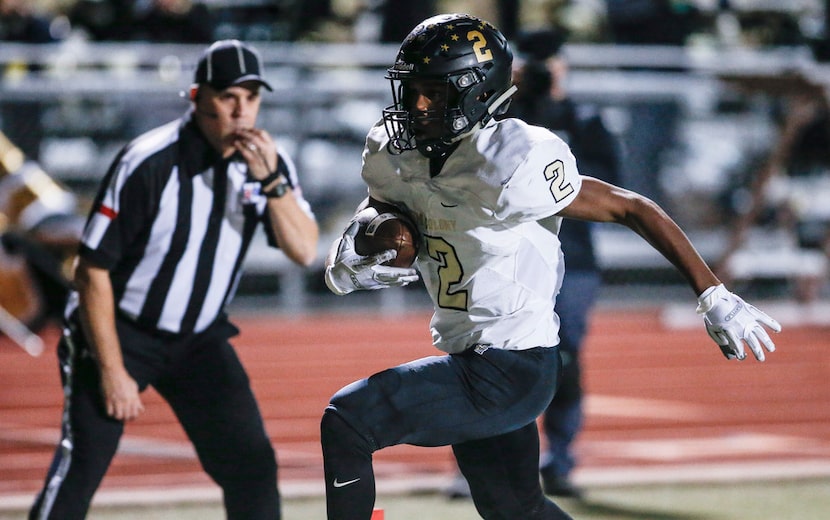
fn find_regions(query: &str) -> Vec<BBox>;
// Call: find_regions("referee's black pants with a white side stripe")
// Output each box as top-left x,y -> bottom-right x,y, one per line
29,318 -> 280,520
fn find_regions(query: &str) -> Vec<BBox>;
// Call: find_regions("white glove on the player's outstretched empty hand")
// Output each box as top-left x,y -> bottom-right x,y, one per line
697,284 -> 781,361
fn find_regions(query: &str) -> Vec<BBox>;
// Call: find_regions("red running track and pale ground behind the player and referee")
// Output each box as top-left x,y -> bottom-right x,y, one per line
0,302 -> 830,520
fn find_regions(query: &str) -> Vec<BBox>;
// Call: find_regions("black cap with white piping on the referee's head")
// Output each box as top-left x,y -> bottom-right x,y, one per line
194,40 -> 274,90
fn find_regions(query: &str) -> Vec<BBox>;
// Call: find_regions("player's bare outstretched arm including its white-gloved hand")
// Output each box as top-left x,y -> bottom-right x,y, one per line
559,177 -> 781,361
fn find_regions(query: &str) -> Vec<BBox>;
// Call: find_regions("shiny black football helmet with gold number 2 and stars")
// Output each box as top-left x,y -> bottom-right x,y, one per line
383,14 -> 516,157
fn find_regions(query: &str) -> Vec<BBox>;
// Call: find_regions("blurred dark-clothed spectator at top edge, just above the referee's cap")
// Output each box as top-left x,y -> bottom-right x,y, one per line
130,0 -> 214,43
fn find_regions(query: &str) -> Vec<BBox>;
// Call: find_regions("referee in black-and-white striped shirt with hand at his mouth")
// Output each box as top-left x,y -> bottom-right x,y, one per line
29,40 -> 318,520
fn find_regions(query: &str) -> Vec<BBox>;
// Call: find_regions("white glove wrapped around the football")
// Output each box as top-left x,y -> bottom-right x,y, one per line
326,221 -> 418,296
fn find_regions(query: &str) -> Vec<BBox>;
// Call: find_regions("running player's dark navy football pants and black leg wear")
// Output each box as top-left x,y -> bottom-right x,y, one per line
321,347 -> 570,520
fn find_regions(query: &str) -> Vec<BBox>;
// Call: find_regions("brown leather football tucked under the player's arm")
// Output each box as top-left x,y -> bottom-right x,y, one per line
354,207 -> 418,267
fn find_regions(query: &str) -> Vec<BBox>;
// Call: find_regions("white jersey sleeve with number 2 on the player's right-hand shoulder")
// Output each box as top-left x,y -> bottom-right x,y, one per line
496,134 -> 582,221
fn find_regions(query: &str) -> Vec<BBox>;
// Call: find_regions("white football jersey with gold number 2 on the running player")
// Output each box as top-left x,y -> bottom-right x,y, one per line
362,119 -> 582,353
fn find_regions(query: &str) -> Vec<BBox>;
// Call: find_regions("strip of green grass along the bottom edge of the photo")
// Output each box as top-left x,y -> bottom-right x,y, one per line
0,479 -> 830,520
